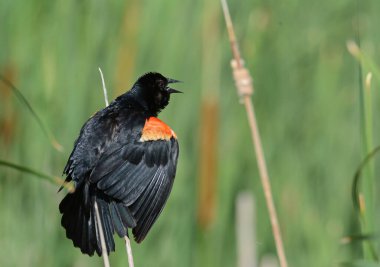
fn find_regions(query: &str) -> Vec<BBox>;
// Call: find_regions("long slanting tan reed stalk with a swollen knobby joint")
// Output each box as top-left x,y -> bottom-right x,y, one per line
221,0 -> 288,267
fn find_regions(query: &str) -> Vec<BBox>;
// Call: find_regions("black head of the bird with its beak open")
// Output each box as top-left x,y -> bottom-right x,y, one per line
132,72 -> 182,114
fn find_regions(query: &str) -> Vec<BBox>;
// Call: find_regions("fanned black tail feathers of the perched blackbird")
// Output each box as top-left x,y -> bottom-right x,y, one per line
59,183 -> 136,256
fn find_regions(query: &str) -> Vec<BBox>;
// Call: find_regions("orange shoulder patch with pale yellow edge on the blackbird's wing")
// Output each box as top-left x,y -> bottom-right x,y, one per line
140,117 -> 177,142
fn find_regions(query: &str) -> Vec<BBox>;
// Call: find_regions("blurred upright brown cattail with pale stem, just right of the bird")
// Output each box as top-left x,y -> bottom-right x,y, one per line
197,1 -> 221,231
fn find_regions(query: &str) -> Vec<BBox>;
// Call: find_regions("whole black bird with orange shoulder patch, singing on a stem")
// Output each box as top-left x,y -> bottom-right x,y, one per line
59,73 -> 180,256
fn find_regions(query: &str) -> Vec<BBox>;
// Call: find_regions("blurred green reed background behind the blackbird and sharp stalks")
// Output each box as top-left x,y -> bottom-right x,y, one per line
0,0 -> 380,267
